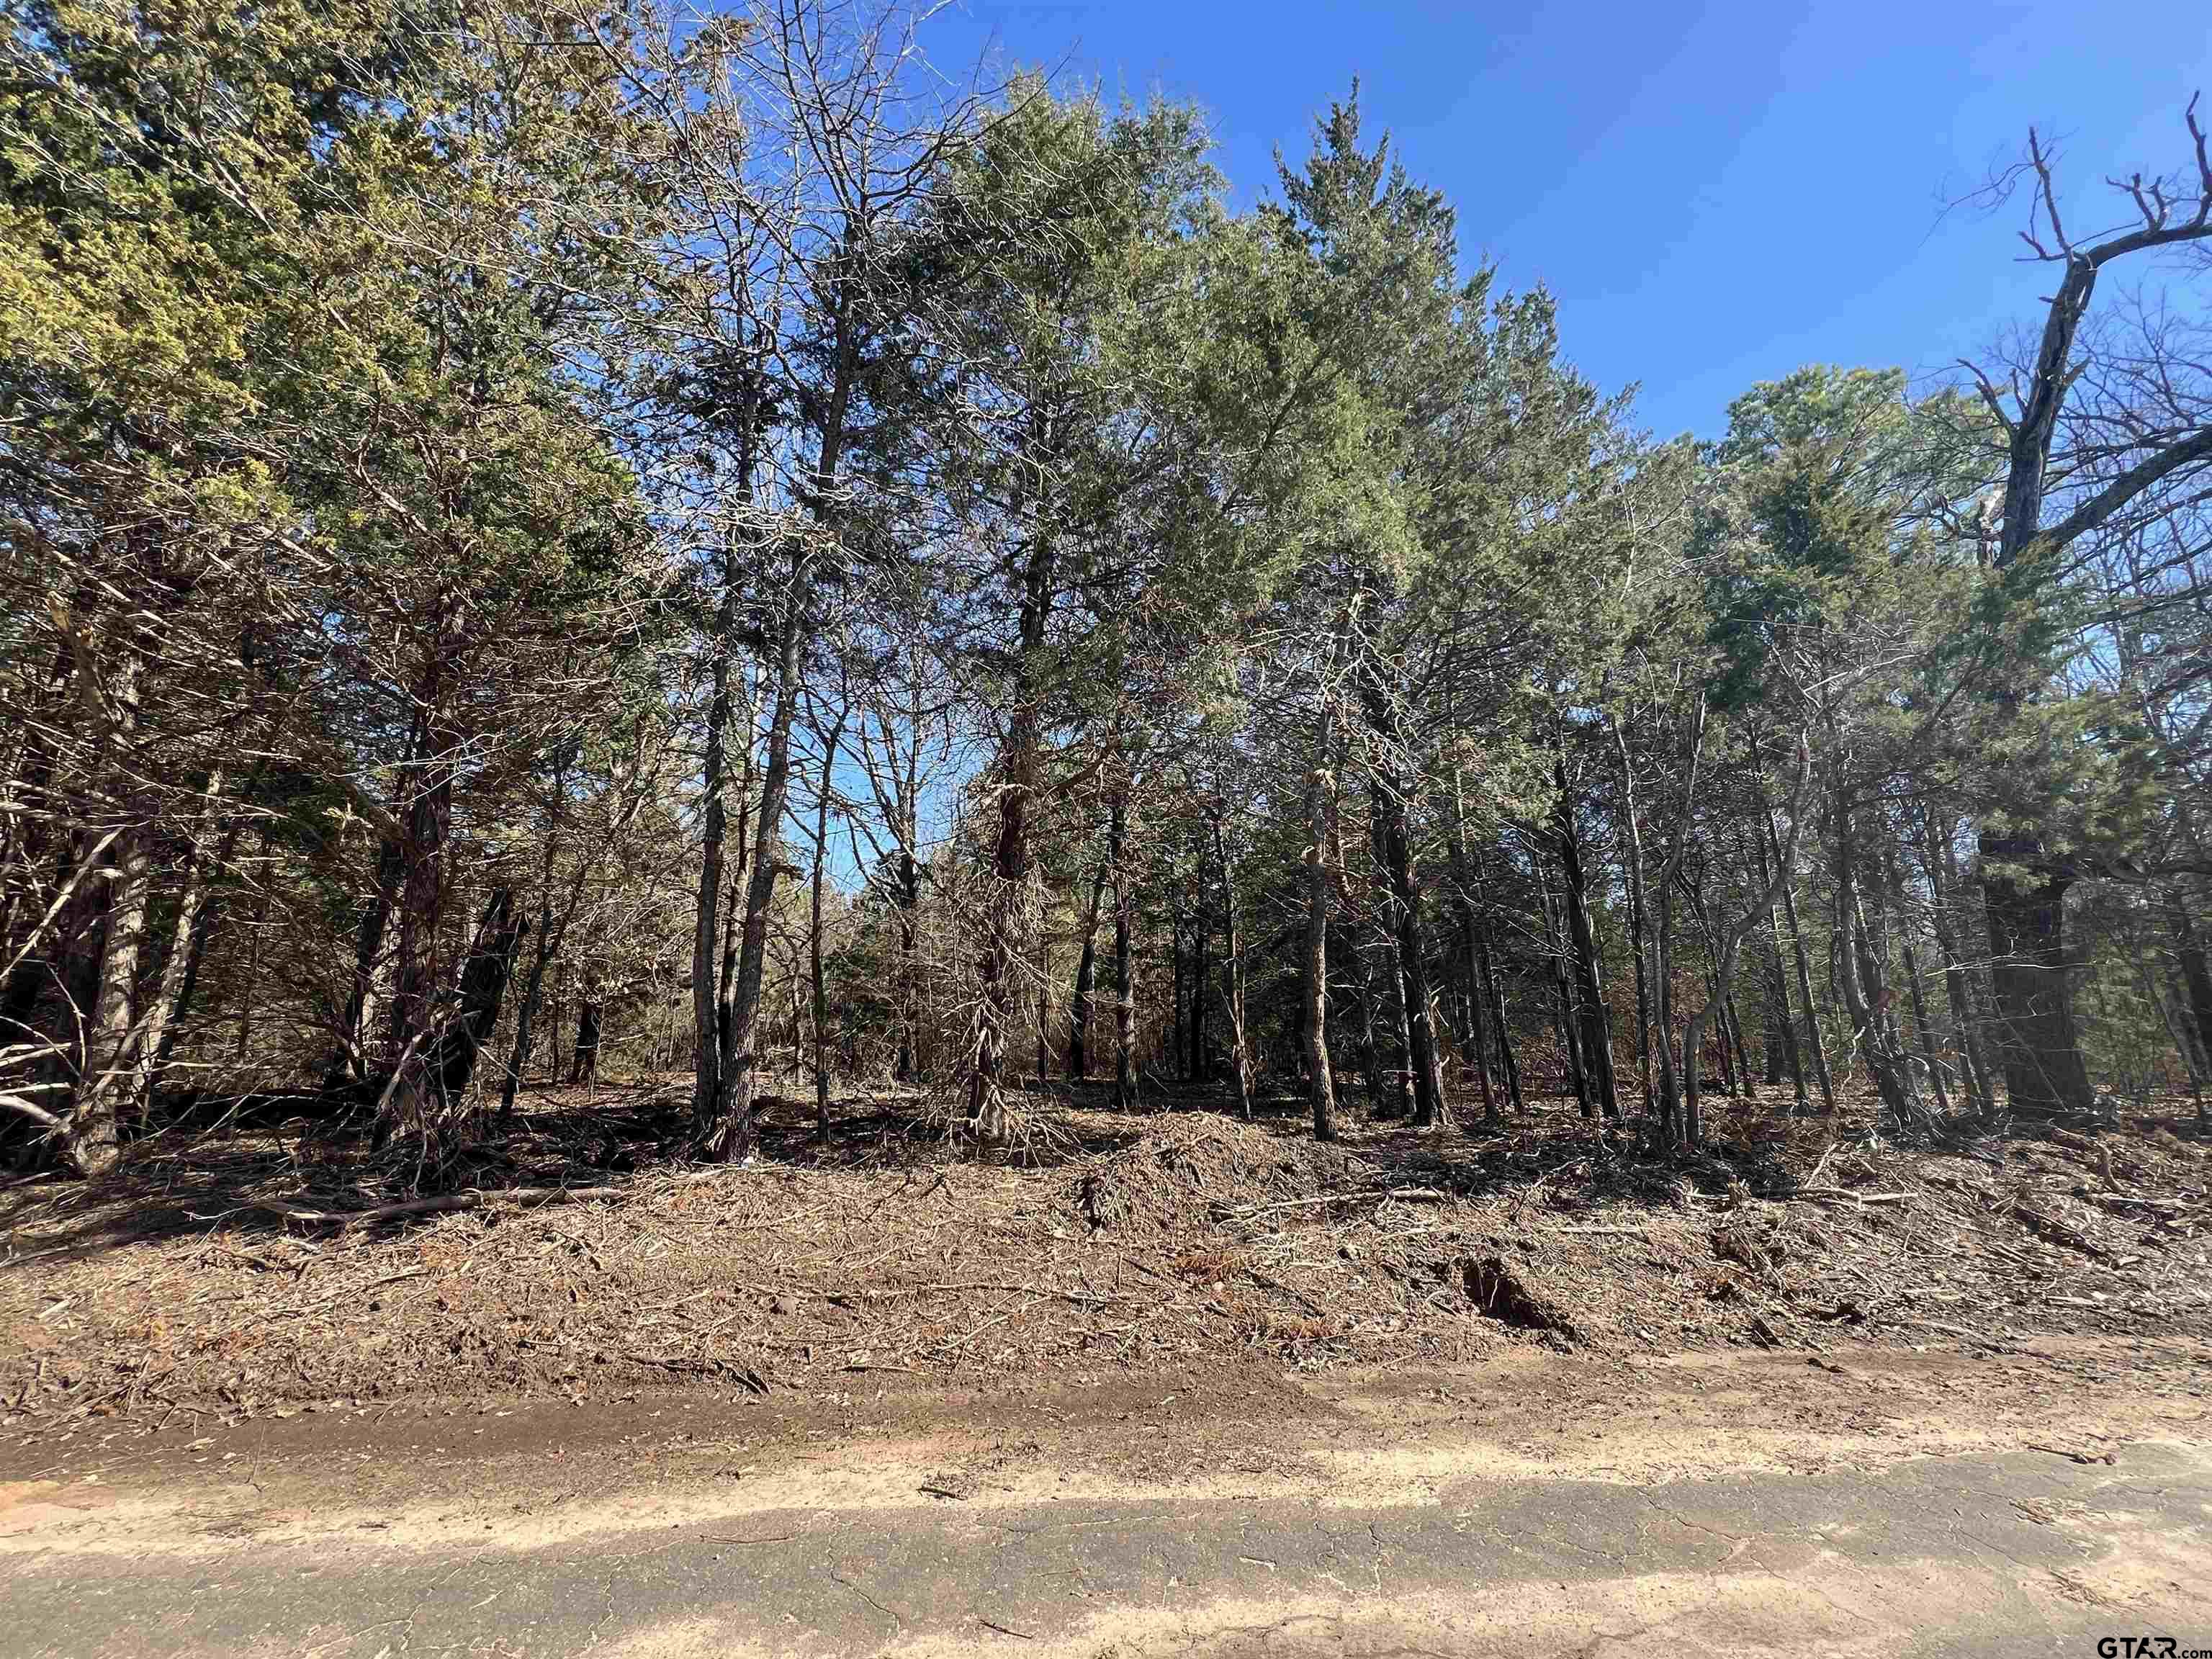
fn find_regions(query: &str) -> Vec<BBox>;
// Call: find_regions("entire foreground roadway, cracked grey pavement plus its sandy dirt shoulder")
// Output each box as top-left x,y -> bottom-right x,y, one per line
0,1341 -> 2212,1659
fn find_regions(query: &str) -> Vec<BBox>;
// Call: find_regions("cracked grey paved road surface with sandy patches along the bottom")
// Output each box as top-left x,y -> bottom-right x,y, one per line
0,1444 -> 2212,1659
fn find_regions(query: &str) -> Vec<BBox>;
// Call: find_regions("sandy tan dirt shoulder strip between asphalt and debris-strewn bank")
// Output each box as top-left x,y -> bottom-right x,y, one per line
0,1339 -> 2212,1555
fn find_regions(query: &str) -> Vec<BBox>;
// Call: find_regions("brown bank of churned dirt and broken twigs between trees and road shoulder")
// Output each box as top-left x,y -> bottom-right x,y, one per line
0,1084 -> 2212,1442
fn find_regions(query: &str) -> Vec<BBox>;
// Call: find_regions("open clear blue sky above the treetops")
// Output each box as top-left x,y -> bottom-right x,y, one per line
925,0 -> 2212,436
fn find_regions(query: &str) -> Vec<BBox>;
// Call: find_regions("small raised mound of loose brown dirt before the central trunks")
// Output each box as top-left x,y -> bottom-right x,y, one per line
1073,1112 -> 1376,1234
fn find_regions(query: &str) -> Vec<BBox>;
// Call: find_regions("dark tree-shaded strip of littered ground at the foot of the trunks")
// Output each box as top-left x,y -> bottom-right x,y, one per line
13,1075 -> 2206,1259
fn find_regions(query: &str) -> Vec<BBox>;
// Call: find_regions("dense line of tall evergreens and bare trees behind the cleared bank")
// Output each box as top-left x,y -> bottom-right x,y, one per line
0,0 -> 2212,1172
